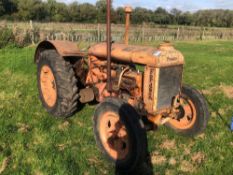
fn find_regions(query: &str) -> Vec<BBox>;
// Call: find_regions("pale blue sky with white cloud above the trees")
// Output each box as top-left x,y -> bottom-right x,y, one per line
58,0 -> 233,11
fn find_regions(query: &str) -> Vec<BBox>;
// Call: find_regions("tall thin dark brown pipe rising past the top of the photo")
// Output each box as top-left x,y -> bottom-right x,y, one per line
106,0 -> 112,92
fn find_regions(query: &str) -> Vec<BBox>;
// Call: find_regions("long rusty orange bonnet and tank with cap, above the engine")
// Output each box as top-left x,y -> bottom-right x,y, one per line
88,43 -> 184,67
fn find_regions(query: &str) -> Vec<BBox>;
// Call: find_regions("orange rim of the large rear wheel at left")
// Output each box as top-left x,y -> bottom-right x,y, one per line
40,65 -> 57,107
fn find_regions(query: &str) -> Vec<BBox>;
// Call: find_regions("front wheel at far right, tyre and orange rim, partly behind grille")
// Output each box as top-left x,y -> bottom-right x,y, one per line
167,86 -> 210,136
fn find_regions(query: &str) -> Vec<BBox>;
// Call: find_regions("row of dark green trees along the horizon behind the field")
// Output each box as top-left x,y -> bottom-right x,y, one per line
0,0 -> 233,27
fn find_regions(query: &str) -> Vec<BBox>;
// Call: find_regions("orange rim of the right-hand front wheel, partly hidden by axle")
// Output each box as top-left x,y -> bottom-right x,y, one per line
169,97 -> 197,130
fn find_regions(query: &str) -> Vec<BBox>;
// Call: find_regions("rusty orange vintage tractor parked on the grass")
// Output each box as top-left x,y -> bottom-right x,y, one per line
35,0 -> 209,172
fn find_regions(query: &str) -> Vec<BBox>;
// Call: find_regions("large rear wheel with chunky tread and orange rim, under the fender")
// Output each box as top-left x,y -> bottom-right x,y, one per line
37,50 -> 78,118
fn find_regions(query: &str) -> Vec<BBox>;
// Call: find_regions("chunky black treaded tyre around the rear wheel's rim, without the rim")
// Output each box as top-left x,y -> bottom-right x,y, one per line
38,50 -> 78,118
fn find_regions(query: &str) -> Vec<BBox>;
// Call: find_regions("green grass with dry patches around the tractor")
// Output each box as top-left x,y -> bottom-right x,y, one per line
0,41 -> 233,175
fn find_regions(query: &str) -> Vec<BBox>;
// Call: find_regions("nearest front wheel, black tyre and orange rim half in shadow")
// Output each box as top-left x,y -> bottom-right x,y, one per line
93,98 -> 147,173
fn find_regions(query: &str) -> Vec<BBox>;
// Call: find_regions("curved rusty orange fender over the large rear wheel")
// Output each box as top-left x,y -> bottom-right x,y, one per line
34,40 -> 86,63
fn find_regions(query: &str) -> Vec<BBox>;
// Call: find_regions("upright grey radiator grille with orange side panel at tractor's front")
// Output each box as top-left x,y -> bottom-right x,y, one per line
143,65 -> 183,114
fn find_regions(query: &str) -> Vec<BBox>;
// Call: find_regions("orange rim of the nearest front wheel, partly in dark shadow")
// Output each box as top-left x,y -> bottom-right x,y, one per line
99,112 -> 129,160
